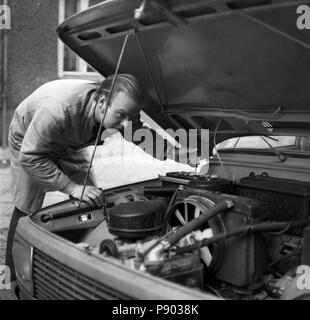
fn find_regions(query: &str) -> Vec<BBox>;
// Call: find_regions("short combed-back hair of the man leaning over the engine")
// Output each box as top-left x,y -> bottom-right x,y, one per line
95,73 -> 148,107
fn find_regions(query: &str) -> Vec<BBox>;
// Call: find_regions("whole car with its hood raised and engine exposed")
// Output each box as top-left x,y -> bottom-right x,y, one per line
13,0 -> 310,300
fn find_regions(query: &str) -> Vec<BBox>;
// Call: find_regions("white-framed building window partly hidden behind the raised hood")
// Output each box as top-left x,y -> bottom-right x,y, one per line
58,0 -> 102,80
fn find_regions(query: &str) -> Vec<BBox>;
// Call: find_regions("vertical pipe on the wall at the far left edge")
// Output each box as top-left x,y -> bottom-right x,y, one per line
1,0 -> 8,149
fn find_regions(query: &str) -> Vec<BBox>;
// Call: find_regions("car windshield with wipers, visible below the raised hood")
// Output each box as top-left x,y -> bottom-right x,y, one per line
217,136 -> 310,153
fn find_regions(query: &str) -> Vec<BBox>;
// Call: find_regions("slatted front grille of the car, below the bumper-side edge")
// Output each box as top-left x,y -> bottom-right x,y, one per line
33,249 -> 129,300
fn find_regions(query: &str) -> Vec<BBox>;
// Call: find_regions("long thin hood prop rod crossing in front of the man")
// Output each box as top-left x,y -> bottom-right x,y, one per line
77,30 -> 135,208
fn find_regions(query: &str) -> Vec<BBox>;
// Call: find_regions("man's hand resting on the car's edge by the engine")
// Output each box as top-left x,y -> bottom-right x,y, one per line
62,182 -> 105,207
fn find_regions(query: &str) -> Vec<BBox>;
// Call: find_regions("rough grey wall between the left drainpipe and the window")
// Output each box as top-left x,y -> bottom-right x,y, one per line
0,0 -> 58,144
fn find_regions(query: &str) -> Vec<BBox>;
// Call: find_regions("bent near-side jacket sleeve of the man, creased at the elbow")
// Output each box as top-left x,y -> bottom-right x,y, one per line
20,99 -> 71,191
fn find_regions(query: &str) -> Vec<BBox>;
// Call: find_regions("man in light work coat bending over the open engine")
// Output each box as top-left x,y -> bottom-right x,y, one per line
6,74 -> 196,280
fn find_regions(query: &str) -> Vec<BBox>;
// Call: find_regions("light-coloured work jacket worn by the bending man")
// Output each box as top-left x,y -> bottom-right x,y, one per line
9,79 -> 169,214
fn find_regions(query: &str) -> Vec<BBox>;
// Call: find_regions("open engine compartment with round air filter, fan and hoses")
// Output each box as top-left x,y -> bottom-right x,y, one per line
32,172 -> 310,300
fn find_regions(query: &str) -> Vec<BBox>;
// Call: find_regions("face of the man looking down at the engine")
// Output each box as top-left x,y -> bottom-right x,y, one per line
100,91 -> 141,130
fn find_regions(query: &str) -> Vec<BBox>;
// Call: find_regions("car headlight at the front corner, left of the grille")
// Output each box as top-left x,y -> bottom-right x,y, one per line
13,235 -> 33,292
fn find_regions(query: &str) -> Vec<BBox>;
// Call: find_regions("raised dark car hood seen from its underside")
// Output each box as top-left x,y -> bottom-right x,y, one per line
58,0 -> 310,140
